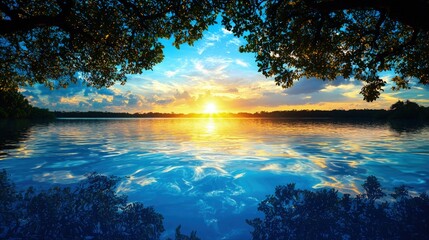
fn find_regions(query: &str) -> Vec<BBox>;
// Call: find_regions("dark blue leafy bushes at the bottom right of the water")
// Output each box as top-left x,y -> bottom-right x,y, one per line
247,176 -> 429,239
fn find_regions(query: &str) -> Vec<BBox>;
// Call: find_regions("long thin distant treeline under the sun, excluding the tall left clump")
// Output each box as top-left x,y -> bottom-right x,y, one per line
54,100 -> 429,121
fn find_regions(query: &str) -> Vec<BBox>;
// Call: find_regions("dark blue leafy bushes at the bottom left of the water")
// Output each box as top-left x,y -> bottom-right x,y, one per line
0,170 -> 198,239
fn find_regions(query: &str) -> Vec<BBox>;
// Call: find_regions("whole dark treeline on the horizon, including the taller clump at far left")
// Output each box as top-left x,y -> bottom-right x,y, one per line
0,89 -> 429,121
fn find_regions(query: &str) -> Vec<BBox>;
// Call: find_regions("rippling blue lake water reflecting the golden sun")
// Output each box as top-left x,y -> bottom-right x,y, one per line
0,119 -> 429,239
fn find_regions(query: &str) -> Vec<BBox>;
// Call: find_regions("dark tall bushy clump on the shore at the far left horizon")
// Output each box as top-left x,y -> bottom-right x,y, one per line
0,88 -> 54,119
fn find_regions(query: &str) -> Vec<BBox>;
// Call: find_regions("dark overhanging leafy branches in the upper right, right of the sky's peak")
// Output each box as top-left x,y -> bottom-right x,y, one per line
223,0 -> 429,101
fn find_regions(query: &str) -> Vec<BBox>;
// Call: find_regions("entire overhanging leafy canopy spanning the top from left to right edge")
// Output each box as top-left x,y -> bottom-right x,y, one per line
0,0 -> 429,101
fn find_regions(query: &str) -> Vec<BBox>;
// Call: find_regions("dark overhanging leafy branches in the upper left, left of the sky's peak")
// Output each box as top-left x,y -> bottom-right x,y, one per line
0,0 -> 218,88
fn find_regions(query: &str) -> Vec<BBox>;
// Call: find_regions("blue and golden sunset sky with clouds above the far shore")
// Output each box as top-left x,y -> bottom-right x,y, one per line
22,21 -> 429,113
